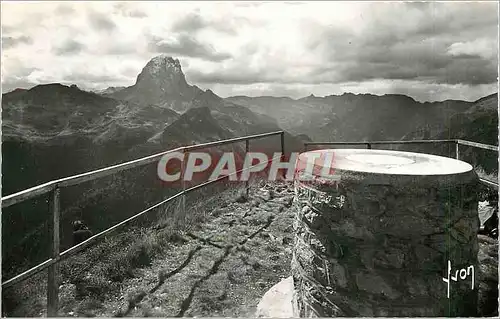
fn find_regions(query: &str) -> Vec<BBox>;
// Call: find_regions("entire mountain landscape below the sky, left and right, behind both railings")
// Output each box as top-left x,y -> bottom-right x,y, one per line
2,55 -> 498,277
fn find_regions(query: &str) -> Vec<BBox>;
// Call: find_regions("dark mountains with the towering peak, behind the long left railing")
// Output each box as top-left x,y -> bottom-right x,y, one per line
2,56 -> 303,275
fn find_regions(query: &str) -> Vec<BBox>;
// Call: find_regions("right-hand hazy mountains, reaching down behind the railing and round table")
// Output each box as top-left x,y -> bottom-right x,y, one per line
226,87 -> 498,173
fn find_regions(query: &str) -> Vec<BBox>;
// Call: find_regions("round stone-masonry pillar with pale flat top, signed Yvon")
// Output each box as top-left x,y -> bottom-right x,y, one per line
292,149 -> 479,317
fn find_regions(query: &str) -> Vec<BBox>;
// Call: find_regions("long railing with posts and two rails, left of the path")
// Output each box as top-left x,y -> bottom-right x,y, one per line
1,131 -> 285,317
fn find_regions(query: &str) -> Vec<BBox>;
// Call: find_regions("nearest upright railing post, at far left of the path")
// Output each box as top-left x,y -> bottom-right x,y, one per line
47,186 -> 61,317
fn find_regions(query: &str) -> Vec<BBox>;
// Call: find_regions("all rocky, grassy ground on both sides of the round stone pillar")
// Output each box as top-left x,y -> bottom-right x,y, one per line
3,183 -> 498,317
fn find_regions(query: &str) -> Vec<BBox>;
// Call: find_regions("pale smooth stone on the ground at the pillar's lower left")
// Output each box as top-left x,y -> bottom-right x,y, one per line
255,276 -> 293,318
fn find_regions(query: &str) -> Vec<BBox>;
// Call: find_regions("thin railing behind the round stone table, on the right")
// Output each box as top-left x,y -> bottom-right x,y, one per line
304,139 -> 498,190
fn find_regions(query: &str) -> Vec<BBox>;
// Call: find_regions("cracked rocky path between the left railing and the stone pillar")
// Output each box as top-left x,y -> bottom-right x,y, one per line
54,184 -> 293,317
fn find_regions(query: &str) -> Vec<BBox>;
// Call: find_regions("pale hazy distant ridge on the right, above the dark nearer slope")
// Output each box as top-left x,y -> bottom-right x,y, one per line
227,93 -> 498,144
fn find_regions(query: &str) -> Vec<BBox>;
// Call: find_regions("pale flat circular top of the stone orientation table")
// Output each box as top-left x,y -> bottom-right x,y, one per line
299,149 -> 473,176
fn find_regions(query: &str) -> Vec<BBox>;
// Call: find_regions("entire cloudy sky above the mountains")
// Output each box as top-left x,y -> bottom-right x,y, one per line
1,1 -> 498,101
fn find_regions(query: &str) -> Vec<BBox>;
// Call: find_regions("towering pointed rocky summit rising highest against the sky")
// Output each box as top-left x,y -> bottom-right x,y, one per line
109,54 -> 202,113
